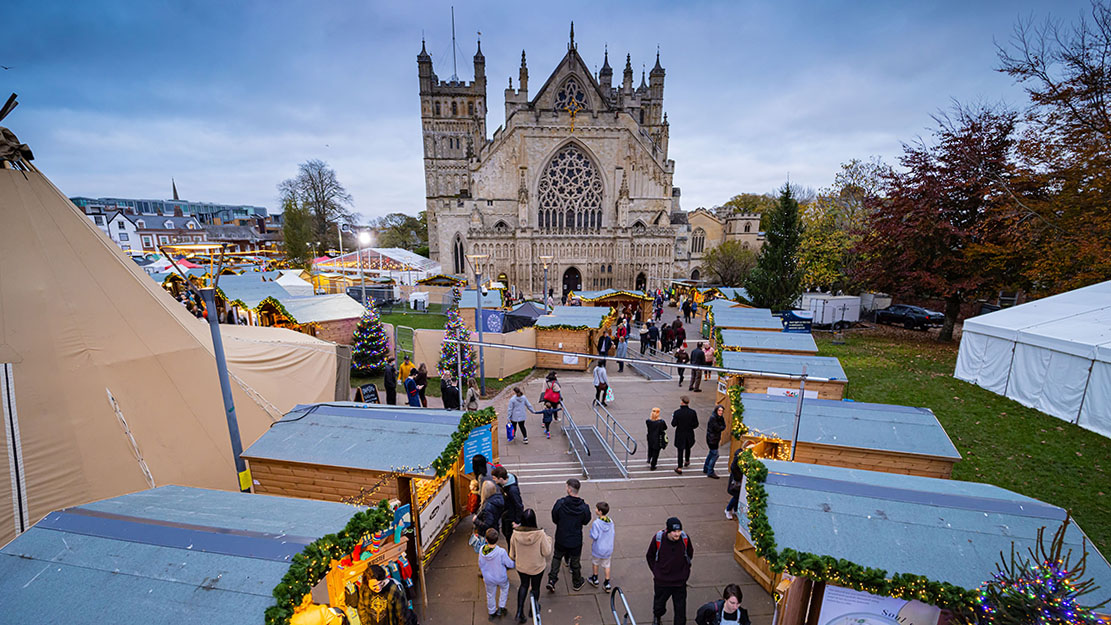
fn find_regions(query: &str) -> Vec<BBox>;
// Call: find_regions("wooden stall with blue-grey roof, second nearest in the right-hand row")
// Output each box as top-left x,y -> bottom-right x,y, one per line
730,393 -> 961,478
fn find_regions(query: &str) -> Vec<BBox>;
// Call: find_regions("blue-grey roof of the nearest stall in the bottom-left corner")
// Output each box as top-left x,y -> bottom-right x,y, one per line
0,486 -> 357,625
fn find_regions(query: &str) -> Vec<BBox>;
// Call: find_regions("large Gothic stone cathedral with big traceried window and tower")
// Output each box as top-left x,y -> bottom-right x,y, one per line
417,24 -> 690,300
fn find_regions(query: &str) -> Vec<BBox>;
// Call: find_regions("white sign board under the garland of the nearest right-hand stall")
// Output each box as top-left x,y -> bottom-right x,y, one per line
818,584 -> 941,625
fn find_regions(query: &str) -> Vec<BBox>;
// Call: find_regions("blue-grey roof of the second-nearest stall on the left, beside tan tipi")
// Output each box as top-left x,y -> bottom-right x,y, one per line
243,402 -> 463,475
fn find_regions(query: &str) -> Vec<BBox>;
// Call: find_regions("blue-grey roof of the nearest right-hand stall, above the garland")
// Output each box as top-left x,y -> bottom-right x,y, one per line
742,459 -> 1111,599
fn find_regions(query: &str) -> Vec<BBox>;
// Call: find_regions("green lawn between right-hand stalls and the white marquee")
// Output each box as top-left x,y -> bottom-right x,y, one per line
814,329 -> 1111,554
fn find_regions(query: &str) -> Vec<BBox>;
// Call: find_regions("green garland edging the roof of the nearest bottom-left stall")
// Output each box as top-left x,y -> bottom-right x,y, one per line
266,500 -> 393,625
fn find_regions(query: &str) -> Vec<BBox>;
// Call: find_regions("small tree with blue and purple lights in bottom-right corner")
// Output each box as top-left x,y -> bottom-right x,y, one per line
968,518 -> 1108,625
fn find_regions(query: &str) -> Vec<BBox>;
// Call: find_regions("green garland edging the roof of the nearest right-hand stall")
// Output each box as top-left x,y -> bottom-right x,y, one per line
740,450 -> 979,613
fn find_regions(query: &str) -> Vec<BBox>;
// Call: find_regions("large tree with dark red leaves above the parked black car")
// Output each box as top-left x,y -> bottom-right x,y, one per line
853,105 -> 1017,341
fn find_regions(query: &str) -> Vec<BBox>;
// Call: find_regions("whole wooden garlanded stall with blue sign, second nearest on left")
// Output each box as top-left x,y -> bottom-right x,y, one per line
242,402 -> 498,590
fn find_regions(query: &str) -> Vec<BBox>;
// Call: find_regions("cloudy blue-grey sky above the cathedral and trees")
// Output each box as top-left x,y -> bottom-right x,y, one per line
0,0 -> 1089,218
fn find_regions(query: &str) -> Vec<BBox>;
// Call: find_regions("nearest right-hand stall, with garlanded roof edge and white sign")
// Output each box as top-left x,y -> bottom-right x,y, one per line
733,456 -> 1111,625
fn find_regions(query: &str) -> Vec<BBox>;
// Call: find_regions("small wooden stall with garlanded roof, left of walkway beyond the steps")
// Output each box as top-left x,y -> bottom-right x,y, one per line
536,306 -> 617,371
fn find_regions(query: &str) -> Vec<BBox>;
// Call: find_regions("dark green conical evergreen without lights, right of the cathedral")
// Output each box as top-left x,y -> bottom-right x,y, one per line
744,184 -> 802,311
